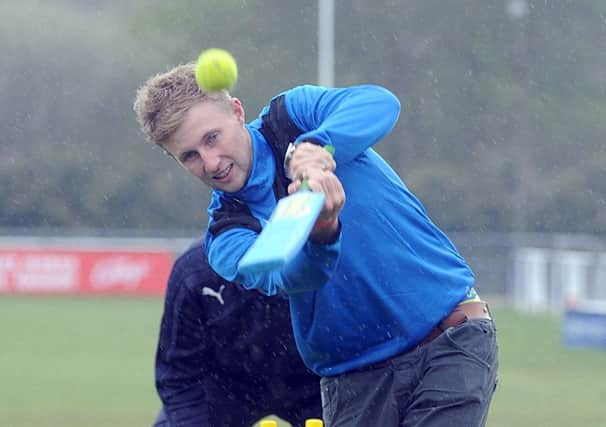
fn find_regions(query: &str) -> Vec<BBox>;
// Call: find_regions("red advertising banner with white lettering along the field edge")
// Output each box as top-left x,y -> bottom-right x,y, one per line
0,248 -> 174,295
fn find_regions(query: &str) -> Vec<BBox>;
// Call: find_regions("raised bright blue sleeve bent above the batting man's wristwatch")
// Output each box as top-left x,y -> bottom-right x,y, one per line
285,85 -> 400,164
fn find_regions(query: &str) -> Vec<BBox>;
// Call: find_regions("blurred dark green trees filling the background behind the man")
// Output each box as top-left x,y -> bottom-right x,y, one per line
0,0 -> 606,233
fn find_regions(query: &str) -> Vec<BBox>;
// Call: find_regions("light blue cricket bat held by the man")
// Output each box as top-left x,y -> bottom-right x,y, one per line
238,146 -> 334,274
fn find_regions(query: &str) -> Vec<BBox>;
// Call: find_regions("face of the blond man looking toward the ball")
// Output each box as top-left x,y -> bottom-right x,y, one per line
163,98 -> 252,193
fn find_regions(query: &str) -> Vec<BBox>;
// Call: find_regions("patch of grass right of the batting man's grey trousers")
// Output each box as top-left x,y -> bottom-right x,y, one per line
488,310 -> 606,427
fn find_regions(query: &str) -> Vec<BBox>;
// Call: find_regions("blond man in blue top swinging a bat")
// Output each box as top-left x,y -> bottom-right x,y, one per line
135,64 -> 498,427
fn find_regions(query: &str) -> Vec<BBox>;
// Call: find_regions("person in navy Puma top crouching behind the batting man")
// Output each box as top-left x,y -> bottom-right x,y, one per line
154,240 -> 322,427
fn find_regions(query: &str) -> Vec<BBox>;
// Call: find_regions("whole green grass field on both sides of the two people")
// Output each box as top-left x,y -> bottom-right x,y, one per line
0,297 -> 606,427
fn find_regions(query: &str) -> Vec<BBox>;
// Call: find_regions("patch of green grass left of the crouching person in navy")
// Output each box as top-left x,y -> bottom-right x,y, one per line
0,297 -> 162,427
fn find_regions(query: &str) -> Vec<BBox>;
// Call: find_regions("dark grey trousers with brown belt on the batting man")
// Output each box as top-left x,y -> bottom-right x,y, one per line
321,319 -> 499,427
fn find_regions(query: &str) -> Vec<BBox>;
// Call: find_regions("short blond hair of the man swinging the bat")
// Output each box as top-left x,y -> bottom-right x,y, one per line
133,63 -> 231,145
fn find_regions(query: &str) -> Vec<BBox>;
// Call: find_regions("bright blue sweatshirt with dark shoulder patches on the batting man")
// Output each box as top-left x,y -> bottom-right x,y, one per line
206,85 -> 474,376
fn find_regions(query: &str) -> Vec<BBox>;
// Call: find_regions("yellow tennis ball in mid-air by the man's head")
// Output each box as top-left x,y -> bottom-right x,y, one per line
196,49 -> 238,92
